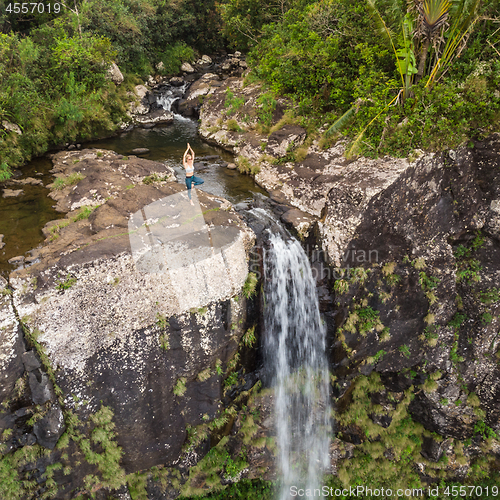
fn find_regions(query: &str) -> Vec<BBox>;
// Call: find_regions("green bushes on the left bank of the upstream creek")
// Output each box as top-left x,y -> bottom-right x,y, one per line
0,0 -> 222,181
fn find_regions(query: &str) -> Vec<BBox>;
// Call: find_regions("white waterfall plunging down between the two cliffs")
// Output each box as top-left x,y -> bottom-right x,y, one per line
264,233 -> 330,500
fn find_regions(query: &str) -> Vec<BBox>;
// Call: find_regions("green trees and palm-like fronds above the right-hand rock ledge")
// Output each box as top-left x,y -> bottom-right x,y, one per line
222,0 -> 500,155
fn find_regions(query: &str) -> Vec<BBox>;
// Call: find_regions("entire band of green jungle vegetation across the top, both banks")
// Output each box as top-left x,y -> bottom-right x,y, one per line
0,0 -> 500,180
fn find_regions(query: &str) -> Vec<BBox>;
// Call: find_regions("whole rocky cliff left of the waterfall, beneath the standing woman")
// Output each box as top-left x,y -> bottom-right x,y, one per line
0,150 -> 254,498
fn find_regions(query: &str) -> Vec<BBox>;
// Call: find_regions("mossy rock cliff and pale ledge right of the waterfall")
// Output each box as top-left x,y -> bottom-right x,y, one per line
190,73 -> 500,485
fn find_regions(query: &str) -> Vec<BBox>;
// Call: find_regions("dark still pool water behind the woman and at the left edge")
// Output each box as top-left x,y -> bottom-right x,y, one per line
0,116 -> 265,277
